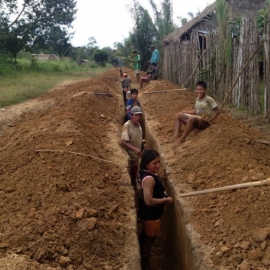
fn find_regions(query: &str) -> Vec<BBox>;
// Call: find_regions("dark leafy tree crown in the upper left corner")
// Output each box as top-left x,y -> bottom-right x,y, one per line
0,0 -> 76,58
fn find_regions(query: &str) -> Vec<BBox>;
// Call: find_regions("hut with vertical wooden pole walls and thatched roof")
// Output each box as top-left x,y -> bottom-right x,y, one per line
162,0 -> 265,114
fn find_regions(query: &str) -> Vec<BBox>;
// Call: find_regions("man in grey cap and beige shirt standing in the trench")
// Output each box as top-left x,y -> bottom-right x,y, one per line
121,106 -> 142,187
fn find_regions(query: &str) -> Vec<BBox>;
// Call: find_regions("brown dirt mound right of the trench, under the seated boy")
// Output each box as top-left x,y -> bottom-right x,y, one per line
140,79 -> 270,269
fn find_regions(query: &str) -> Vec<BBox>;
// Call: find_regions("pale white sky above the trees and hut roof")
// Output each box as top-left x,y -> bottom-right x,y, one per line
71,0 -> 214,48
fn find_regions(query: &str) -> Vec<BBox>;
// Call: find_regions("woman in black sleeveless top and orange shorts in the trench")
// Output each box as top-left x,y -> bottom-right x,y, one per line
138,150 -> 173,270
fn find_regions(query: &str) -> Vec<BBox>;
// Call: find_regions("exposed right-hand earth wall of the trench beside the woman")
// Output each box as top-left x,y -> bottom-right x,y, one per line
121,110 -> 199,270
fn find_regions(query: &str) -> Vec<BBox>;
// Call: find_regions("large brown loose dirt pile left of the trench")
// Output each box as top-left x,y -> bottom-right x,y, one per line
0,70 -> 139,270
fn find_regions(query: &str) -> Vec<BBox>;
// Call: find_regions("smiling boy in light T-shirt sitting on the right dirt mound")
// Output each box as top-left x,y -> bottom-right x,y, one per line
169,81 -> 219,146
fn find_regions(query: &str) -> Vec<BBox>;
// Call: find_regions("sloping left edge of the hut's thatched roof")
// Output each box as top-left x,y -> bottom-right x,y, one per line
163,2 -> 216,42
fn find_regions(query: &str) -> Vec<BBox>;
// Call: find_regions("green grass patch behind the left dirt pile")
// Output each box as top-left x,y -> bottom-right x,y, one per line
0,60 -> 110,107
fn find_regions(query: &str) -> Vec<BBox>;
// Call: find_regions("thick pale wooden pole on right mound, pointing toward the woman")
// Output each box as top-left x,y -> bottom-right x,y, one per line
179,178 -> 270,198
